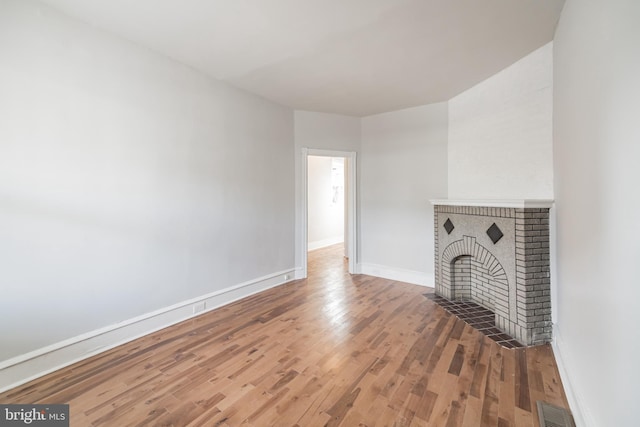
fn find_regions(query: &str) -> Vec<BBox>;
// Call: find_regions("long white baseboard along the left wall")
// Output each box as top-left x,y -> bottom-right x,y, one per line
0,269 -> 295,393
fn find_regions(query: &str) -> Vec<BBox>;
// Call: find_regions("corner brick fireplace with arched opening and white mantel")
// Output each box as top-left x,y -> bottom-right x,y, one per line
432,200 -> 552,345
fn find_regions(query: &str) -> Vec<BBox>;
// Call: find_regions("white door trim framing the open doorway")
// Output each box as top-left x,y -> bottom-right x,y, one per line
298,148 -> 358,278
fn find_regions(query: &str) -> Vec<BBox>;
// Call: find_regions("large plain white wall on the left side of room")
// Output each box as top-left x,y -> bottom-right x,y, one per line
0,0 -> 294,368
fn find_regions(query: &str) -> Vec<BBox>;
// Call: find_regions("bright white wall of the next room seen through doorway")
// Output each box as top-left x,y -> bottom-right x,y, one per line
307,156 -> 345,250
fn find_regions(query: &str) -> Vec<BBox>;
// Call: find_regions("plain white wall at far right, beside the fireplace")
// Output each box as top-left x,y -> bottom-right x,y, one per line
553,0 -> 640,427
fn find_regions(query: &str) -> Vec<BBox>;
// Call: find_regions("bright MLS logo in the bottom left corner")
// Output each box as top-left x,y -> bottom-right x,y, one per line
0,405 -> 69,427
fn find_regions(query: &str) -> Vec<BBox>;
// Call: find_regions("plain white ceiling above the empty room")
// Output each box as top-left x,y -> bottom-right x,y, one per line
43,0 -> 564,116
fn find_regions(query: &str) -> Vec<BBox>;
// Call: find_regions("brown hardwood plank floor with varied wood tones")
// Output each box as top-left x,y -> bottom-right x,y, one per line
0,245 -> 568,427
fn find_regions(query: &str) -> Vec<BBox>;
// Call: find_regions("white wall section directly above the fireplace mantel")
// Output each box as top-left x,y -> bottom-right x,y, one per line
448,43 -> 553,199
